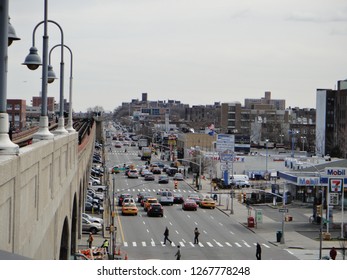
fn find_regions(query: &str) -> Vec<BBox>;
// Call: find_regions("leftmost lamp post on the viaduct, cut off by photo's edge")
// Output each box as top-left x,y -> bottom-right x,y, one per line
0,0 -> 19,155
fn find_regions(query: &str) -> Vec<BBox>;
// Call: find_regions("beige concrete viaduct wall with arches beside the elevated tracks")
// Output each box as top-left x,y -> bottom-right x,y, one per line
0,128 -> 95,259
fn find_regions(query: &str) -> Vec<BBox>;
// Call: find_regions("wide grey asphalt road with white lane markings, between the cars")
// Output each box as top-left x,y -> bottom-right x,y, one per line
106,138 -> 296,260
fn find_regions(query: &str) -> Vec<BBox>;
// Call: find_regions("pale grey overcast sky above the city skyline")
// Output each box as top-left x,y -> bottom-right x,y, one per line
7,0 -> 347,112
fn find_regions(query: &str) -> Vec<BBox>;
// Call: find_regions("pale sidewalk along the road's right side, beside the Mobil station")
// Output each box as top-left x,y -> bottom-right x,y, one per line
190,178 -> 343,260
